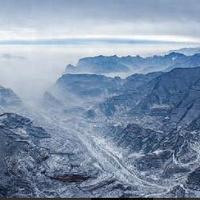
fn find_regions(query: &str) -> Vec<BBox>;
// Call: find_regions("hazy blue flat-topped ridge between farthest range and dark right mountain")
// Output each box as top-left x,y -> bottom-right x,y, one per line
43,72 -> 162,115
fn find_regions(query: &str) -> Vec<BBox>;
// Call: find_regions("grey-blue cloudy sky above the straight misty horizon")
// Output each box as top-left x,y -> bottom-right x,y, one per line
0,0 -> 200,44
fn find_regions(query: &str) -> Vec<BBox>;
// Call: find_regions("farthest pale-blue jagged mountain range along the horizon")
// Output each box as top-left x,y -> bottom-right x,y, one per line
65,52 -> 200,75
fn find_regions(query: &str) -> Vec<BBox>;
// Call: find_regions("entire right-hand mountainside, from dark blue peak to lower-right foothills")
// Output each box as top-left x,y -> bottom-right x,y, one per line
98,68 -> 200,197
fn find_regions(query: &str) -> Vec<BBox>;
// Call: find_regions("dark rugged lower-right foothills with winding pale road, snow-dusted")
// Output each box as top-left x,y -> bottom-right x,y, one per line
94,117 -> 200,197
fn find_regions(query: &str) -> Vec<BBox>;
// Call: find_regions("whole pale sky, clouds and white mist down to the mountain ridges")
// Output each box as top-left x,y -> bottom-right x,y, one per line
0,0 -> 200,99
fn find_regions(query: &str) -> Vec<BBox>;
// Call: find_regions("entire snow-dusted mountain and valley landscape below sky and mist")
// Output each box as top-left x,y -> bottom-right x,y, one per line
0,47 -> 200,198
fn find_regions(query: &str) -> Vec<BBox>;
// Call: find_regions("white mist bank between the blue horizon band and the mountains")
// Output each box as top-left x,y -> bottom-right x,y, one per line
0,44 -> 198,100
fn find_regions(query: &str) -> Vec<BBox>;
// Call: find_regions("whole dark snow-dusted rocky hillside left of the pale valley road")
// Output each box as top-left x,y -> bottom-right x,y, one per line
0,113 -> 134,198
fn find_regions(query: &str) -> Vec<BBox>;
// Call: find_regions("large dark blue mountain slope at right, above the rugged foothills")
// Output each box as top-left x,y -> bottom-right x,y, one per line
100,68 -> 200,124
